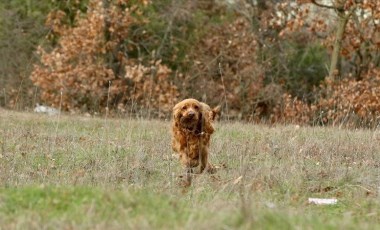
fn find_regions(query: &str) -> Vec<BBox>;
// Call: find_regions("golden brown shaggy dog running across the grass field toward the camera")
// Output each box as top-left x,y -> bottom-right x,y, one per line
172,98 -> 220,173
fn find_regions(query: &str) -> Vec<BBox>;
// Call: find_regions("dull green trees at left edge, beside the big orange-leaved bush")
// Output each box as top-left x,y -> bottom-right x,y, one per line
0,0 -> 87,109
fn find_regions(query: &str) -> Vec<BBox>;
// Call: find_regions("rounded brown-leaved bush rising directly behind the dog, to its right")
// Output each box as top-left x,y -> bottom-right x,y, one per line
182,17 -> 264,117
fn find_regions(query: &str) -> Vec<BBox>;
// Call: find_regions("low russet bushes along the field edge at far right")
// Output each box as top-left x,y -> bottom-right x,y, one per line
271,67 -> 380,127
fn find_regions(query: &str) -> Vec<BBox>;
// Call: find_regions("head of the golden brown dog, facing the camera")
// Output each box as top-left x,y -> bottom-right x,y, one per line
173,98 -> 203,131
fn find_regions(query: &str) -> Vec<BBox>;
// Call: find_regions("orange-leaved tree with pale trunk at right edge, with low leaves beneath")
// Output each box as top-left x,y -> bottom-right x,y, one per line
284,0 -> 380,125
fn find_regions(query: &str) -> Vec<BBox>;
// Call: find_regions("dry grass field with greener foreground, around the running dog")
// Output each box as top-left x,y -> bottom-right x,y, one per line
0,110 -> 380,229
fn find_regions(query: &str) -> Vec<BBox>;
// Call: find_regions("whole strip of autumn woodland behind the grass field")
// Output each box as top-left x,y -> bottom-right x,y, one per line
0,0 -> 380,127
